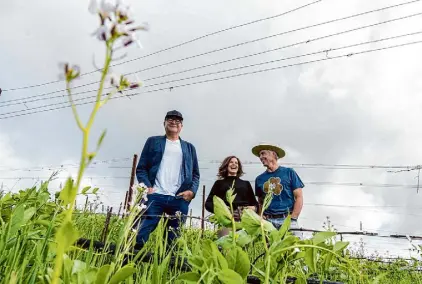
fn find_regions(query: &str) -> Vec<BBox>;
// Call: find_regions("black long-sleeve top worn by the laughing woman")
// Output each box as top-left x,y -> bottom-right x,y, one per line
205,176 -> 258,213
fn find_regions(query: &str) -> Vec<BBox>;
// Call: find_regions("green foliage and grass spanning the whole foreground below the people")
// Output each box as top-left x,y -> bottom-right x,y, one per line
0,183 -> 422,283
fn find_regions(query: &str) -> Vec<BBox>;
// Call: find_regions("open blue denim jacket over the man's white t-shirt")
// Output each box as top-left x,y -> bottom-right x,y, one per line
136,135 -> 199,195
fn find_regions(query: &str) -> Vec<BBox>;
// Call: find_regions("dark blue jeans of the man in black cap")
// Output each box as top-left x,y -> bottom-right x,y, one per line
136,193 -> 189,247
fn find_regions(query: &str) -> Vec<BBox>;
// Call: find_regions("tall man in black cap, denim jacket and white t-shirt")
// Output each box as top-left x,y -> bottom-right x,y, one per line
136,110 -> 199,248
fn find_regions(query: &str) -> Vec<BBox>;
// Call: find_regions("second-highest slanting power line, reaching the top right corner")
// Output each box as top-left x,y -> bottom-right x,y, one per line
0,0 -> 422,98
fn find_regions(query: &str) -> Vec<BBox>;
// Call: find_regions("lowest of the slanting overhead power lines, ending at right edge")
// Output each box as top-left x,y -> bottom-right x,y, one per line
0,37 -> 422,120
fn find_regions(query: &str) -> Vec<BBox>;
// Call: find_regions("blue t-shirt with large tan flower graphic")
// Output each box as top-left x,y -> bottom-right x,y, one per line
255,167 -> 305,215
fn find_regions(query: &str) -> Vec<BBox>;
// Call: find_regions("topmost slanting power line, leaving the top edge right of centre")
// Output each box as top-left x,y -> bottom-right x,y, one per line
3,0 -> 322,92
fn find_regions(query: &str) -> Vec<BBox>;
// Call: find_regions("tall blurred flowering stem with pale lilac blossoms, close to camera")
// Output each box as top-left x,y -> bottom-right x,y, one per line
46,0 -> 145,284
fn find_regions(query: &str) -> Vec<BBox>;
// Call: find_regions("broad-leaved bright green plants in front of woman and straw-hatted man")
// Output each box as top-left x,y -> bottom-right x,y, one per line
179,182 -> 358,284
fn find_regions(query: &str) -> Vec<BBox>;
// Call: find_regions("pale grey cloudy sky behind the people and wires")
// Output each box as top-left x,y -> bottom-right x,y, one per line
0,0 -> 422,258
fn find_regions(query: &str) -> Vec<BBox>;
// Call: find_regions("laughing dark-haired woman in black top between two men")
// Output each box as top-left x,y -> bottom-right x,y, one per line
205,156 -> 258,226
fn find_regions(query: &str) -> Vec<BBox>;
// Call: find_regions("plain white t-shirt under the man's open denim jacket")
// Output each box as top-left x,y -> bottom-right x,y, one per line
154,139 -> 183,196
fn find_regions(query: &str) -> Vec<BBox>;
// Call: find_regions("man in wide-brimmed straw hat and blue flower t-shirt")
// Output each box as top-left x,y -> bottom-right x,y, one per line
252,144 -> 304,232
